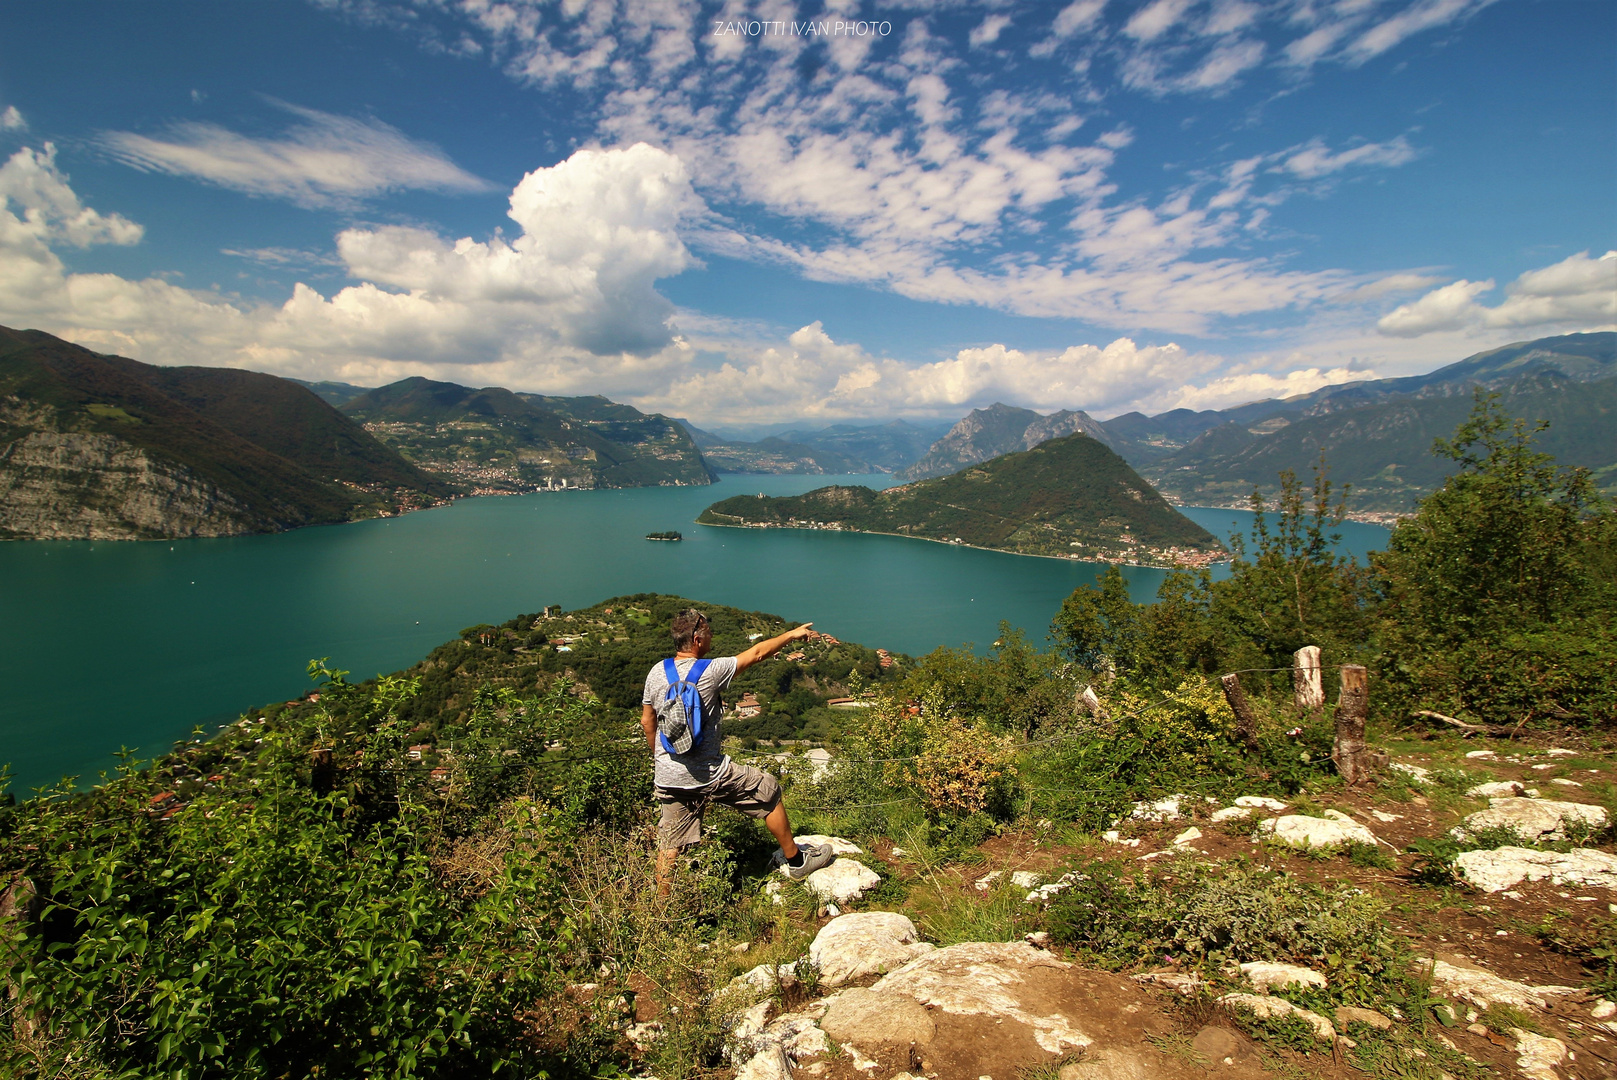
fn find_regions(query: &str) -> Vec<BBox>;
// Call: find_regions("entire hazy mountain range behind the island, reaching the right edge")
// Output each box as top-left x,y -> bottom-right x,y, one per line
901,331 -> 1617,517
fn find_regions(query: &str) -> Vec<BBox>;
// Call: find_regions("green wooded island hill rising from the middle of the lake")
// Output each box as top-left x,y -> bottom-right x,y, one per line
697,433 -> 1221,564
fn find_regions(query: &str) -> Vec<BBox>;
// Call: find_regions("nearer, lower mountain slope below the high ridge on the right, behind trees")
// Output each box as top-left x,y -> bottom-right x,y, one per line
1142,369 -> 1617,514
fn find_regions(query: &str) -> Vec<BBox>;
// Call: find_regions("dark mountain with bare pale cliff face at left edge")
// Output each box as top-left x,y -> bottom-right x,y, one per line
0,327 -> 451,540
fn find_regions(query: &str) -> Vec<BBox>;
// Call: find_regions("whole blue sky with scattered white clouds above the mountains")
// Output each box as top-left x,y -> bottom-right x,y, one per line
0,0 -> 1617,425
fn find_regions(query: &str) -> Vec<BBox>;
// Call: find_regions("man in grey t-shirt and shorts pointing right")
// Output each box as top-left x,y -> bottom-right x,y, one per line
640,608 -> 831,896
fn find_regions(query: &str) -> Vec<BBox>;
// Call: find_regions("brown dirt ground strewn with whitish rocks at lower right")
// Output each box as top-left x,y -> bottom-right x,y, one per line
632,734 -> 1617,1080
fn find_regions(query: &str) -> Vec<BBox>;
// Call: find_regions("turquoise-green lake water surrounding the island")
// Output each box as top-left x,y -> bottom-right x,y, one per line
0,475 -> 1387,795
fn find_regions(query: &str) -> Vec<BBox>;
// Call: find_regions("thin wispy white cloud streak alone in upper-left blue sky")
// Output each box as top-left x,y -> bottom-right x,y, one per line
100,102 -> 492,207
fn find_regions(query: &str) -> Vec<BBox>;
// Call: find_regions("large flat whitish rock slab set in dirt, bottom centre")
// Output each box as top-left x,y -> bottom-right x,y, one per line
872,941 -> 1091,1054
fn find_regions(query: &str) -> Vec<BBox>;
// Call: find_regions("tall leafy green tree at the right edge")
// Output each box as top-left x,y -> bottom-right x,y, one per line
1373,390 -> 1617,723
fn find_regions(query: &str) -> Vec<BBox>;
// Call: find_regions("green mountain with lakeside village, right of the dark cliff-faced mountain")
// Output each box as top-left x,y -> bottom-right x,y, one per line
343,377 -> 713,493
